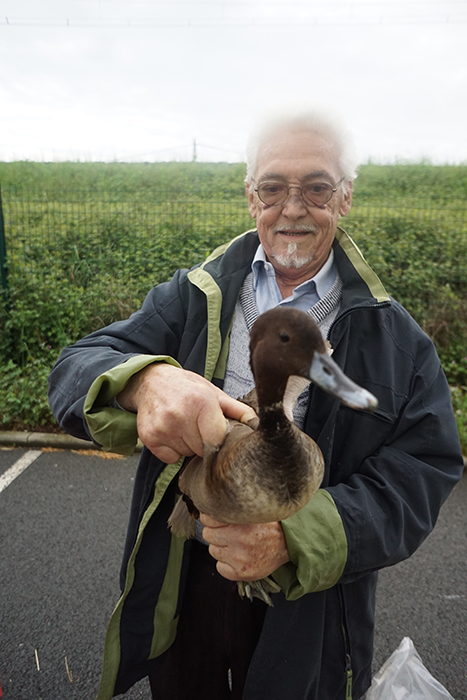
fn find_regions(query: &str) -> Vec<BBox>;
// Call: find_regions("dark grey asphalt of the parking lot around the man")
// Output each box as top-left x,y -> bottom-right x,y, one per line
0,449 -> 467,700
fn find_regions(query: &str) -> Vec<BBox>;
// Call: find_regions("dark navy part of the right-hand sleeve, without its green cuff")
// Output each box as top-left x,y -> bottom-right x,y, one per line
329,351 -> 463,582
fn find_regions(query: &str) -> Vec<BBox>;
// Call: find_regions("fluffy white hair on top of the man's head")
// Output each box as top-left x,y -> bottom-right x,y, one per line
245,106 -> 358,192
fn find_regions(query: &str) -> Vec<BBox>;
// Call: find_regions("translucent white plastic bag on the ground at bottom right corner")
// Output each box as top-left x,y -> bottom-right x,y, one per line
364,637 -> 454,700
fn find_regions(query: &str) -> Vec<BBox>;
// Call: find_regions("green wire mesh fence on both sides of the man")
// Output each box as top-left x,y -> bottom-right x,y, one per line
0,189 -> 467,322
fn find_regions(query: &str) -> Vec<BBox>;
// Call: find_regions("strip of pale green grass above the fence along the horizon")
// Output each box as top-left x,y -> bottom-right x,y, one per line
0,161 -> 467,200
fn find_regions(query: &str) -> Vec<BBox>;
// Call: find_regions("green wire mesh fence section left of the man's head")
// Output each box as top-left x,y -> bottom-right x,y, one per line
0,190 -> 252,314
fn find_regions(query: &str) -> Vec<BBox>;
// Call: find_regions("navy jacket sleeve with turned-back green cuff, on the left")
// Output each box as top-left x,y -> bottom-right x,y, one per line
49,270 -> 190,442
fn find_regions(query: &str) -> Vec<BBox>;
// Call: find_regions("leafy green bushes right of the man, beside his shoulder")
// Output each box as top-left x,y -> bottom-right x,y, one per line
347,210 -> 467,385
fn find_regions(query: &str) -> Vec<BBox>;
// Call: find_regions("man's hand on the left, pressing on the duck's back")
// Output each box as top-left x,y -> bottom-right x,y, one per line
117,362 -> 256,464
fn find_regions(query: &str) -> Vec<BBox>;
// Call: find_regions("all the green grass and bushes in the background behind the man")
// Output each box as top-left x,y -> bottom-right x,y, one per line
0,162 -> 467,448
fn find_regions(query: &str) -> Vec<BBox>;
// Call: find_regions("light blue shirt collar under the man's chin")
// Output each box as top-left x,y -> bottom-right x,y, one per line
251,243 -> 336,314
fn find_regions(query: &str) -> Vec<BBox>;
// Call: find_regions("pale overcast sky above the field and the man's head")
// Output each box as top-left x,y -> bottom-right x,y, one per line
0,0 -> 467,163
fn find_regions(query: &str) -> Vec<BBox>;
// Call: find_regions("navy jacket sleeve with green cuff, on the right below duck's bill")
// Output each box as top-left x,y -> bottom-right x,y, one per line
274,314 -> 463,599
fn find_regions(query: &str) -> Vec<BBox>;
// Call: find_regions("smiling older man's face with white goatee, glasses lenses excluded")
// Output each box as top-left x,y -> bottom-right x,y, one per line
247,131 -> 351,281
